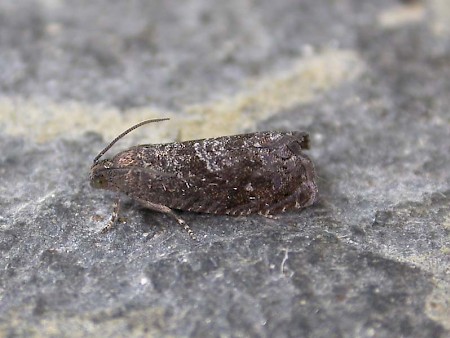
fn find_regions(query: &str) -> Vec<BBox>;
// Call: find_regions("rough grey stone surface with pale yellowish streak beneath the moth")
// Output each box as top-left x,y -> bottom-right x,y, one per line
0,0 -> 450,337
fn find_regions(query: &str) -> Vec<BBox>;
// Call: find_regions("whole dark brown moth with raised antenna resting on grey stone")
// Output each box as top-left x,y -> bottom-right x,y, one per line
90,118 -> 318,239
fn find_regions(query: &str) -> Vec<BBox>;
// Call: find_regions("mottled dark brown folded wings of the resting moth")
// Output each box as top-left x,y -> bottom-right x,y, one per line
120,132 -> 313,215
